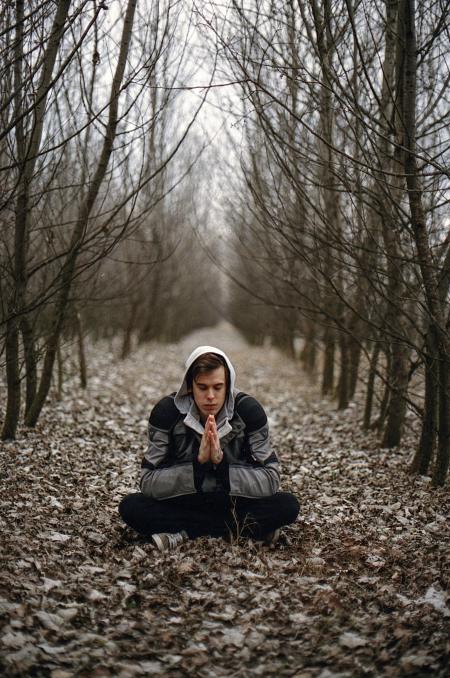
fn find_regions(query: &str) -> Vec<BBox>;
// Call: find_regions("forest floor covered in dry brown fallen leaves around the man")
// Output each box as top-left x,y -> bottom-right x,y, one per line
0,327 -> 450,678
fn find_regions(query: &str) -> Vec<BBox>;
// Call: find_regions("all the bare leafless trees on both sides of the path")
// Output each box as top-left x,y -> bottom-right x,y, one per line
0,0 -> 450,484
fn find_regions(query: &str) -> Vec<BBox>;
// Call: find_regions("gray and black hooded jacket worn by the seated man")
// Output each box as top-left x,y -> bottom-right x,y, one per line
141,346 -> 280,499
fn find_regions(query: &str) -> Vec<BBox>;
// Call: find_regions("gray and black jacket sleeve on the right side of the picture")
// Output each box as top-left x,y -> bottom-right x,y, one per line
229,395 -> 280,498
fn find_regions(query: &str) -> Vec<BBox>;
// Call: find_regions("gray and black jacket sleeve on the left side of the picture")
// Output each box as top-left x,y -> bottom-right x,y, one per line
140,396 -> 196,499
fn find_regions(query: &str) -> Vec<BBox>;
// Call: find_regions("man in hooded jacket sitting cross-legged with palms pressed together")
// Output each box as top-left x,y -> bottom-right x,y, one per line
119,346 -> 299,551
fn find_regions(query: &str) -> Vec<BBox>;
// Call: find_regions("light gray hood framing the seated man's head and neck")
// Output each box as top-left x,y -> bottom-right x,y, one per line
175,346 -> 238,438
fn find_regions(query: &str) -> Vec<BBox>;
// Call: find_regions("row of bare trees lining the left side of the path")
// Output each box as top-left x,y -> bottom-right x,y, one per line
0,0 -> 220,439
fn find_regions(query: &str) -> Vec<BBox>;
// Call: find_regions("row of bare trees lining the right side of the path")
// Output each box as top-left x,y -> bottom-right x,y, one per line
198,0 -> 450,484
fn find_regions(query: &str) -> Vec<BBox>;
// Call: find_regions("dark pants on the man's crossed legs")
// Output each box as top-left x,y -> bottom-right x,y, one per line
119,492 -> 299,539
